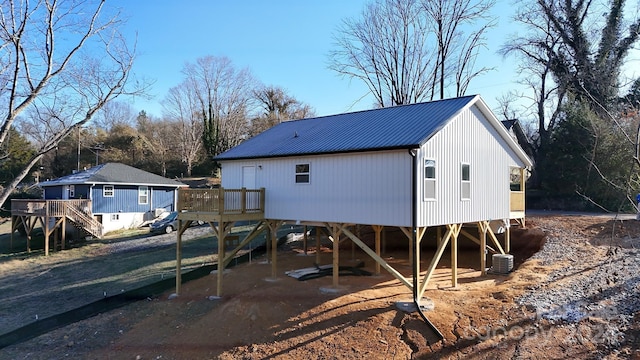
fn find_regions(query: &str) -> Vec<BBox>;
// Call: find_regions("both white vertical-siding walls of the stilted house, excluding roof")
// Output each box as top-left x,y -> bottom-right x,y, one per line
222,106 -> 524,226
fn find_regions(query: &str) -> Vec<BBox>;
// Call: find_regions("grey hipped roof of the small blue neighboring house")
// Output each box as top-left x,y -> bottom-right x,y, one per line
39,163 -> 187,187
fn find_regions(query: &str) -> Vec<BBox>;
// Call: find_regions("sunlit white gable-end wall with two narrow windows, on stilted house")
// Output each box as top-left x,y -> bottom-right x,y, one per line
418,106 -> 522,226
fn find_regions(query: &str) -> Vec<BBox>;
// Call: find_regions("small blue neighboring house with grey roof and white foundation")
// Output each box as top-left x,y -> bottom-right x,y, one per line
39,163 -> 187,233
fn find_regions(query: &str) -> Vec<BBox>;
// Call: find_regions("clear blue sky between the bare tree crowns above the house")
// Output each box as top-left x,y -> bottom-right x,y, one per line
110,0 -> 528,117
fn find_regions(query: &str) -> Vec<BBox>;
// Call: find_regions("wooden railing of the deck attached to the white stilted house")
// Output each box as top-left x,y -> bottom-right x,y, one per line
178,188 -> 264,215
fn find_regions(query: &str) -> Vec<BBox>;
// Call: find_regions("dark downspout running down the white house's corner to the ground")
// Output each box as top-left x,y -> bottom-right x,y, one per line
409,149 -> 444,341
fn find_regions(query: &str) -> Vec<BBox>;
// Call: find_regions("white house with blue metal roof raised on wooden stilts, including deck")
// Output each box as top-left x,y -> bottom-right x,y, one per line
176,95 -> 532,301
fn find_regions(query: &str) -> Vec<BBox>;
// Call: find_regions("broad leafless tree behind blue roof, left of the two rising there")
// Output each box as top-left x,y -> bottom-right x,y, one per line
329,0 -> 435,107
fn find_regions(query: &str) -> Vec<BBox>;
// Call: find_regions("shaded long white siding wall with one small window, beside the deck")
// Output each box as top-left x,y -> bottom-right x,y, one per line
222,150 -> 412,226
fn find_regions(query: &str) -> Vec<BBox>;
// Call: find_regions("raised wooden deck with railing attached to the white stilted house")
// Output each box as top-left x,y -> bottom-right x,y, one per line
176,188 -> 265,222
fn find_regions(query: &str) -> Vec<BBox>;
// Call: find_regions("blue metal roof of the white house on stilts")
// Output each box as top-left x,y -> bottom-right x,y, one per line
214,95 -> 477,160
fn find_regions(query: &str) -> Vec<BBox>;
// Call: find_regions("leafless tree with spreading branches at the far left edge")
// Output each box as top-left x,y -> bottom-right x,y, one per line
0,0 -> 140,207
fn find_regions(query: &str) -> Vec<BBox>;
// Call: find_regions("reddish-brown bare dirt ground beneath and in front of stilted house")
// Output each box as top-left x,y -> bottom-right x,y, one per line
0,216 -> 640,360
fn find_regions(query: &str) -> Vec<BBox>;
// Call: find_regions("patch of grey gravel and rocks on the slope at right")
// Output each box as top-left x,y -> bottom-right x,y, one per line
516,218 -> 640,353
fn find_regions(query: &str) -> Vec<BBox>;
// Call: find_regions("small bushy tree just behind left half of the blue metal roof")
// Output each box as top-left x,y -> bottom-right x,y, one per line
249,86 -> 315,136
